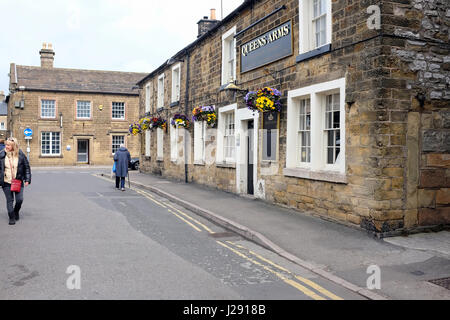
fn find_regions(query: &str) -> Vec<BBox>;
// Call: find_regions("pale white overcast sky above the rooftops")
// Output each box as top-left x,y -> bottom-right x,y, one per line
0,0 -> 243,93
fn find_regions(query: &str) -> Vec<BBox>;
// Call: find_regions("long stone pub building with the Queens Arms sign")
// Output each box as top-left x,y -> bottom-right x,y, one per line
138,0 -> 450,235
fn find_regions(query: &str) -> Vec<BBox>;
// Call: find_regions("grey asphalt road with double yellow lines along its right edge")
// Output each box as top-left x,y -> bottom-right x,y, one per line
0,168 -> 362,300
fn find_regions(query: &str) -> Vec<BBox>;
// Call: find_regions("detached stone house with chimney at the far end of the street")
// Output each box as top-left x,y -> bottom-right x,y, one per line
8,44 -> 146,166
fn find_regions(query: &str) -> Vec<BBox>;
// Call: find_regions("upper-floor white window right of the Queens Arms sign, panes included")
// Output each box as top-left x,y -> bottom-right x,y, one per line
299,0 -> 332,53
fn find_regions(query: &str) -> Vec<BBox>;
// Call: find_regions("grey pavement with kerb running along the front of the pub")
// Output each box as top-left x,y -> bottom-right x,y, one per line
100,169 -> 450,300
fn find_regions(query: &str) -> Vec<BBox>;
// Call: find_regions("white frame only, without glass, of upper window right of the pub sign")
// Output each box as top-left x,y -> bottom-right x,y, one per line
299,0 -> 332,54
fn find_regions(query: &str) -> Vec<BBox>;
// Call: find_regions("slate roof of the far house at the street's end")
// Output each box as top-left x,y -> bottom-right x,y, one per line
16,65 -> 147,95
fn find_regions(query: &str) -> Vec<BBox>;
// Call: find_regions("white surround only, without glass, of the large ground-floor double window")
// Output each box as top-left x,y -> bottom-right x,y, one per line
286,78 -> 346,180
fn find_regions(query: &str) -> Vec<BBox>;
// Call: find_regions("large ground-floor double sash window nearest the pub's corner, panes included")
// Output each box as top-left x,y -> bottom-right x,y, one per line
286,78 -> 345,174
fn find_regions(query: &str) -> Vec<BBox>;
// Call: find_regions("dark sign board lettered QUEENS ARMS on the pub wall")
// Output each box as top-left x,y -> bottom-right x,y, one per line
240,20 -> 293,73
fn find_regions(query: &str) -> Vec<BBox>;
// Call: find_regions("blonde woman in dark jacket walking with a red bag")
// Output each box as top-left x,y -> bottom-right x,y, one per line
0,137 -> 31,225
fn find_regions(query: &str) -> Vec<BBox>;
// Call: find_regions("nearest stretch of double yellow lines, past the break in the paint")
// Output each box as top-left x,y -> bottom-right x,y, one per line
217,241 -> 343,300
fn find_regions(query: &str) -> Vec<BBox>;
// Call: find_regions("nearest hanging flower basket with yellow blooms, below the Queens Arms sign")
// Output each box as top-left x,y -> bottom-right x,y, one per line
245,87 -> 281,112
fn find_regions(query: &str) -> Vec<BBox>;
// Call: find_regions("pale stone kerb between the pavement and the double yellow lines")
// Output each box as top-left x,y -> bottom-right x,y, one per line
99,174 -> 390,300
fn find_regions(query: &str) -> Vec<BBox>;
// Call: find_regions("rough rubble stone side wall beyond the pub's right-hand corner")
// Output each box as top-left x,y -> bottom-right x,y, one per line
384,0 -> 450,226
